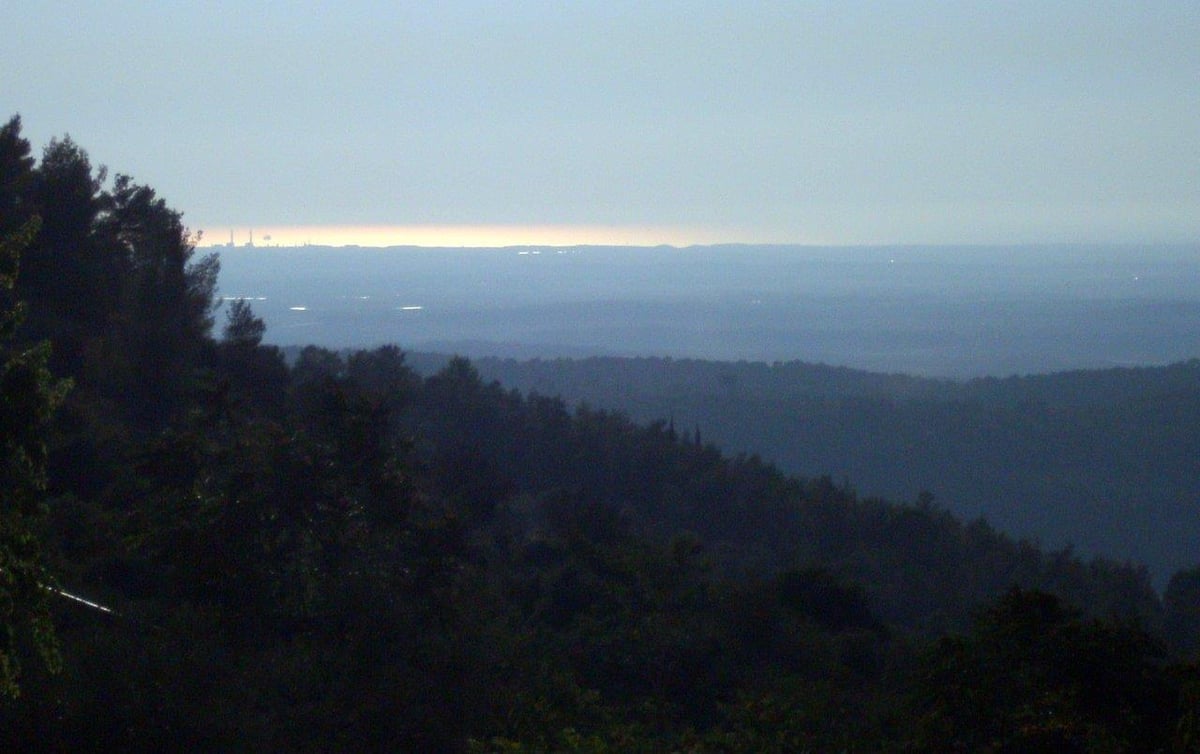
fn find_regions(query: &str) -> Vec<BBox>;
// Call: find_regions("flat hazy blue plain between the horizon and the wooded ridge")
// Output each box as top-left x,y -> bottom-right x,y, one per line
220,245 -> 1200,378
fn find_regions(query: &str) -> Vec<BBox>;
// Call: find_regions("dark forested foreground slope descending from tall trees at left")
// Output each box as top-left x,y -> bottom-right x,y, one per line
0,119 -> 1200,752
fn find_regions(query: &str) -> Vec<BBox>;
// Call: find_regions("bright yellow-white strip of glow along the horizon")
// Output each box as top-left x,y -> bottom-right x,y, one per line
200,225 -> 817,247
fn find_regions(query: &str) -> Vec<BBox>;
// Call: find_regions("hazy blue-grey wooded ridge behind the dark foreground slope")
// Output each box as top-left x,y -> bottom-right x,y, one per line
410,354 -> 1200,584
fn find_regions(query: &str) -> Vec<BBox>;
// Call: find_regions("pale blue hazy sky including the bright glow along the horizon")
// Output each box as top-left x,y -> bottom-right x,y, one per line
0,0 -> 1200,246
